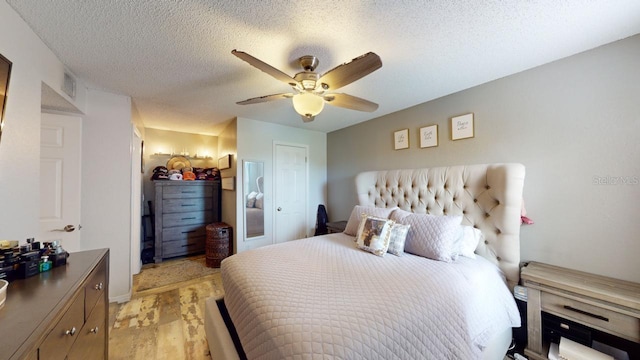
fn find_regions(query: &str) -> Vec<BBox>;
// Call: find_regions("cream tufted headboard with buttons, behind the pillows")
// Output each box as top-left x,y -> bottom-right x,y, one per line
356,164 -> 525,289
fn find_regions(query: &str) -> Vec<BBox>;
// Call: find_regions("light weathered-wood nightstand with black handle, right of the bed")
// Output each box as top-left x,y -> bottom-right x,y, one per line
520,262 -> 640,360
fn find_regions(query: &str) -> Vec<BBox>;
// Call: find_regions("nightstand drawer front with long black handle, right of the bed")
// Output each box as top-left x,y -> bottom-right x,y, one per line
540,292 -> 640,342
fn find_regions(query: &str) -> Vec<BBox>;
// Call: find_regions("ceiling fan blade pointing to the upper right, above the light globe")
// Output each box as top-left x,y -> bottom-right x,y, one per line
318,52 -> 382,90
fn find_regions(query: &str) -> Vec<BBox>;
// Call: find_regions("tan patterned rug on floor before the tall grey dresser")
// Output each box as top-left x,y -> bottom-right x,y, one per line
133,256 -> 220,295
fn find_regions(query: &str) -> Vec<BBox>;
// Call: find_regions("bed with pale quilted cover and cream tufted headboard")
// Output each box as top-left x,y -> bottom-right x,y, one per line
205,164 -> 525,359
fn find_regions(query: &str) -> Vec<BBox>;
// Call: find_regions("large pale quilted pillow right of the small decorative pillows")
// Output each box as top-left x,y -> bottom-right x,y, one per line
401,214 -> 462,262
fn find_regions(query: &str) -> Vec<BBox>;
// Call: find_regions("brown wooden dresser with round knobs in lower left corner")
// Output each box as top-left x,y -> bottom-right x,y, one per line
0,249 -> 109,360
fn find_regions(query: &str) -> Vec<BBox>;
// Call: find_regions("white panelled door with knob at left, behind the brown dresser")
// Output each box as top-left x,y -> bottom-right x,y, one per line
36,113 -> 82,252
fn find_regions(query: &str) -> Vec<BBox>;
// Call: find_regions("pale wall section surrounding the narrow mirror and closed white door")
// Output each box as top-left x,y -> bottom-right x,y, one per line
234,118 -> 327,251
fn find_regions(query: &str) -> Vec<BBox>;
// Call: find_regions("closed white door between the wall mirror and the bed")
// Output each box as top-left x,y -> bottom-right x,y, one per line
274,144 -> 307,243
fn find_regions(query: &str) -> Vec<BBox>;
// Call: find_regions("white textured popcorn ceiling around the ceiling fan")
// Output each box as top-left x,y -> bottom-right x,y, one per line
6,0 -> 640,135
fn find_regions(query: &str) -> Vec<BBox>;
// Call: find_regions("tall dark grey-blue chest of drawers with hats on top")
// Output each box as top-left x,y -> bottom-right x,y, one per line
154,180 -> 221,262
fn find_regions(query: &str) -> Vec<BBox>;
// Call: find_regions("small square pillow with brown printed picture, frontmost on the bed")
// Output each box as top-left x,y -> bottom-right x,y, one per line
356,214 -> 395,256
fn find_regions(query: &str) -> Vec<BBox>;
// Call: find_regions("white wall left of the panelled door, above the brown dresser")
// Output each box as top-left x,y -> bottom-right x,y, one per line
0,1 -> 84,242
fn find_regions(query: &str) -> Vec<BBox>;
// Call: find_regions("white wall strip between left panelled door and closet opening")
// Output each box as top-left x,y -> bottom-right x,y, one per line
82,90 -> 133,301
